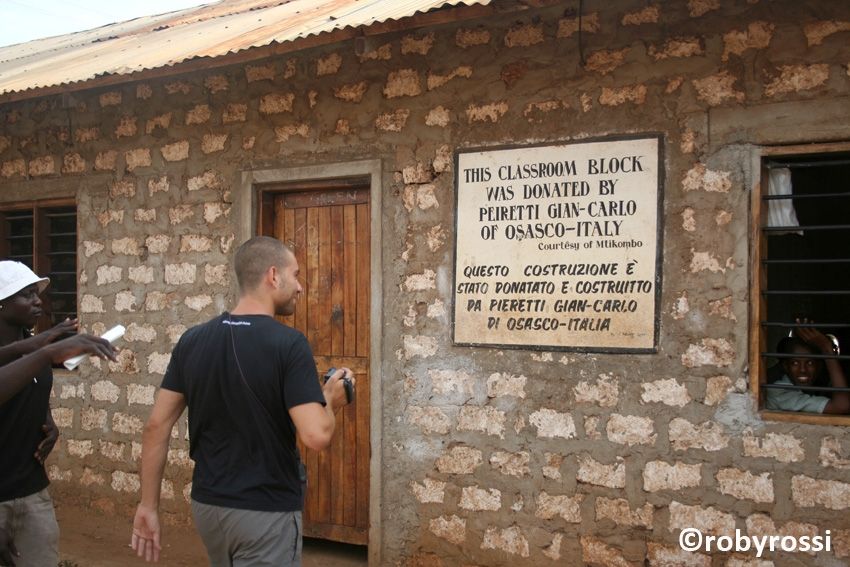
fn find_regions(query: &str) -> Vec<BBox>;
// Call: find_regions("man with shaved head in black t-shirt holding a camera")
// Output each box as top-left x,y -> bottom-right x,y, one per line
131,236 -> 353,566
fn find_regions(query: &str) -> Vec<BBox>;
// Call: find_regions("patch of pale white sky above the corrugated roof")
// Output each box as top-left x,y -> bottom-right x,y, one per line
0,0 -> 212,46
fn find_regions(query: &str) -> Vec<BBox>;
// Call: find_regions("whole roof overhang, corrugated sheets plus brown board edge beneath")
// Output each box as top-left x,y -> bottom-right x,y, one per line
0,0 -> 528,103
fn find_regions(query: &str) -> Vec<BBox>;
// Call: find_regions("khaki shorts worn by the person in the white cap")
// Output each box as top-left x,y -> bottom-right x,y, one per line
0,488 -> 59,567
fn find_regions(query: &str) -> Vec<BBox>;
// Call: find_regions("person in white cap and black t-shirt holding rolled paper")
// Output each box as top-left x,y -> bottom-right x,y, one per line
0,260 -> 115,567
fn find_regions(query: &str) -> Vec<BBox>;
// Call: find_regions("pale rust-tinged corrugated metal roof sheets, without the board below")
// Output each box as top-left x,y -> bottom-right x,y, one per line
0,0 -> 491,96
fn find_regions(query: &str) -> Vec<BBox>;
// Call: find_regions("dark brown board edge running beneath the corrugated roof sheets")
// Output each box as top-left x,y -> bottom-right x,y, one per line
0,0 -> 496,104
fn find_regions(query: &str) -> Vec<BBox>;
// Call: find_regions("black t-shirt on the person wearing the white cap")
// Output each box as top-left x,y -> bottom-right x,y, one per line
0,365 -> 53,502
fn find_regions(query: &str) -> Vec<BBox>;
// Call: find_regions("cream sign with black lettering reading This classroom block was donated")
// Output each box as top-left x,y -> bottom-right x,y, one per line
453,135 -> 662,352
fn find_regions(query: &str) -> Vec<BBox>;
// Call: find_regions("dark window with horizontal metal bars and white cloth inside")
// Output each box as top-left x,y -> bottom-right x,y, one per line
753,152 -> 850,424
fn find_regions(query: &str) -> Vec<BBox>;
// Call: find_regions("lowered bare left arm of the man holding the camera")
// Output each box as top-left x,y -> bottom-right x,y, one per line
130,388 -> 186,561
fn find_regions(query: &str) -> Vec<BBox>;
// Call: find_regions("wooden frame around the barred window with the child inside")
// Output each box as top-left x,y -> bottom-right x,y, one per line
749,142 -> 850,426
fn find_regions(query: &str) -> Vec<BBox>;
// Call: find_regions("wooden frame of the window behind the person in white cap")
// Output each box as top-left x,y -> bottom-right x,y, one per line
0,197 -> 80,332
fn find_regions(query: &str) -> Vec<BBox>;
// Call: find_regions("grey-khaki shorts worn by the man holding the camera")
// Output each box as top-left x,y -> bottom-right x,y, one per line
192,500 -> 301,567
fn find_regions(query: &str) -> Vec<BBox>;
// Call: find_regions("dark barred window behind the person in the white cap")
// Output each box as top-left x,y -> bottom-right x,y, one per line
0,201 -> 77,331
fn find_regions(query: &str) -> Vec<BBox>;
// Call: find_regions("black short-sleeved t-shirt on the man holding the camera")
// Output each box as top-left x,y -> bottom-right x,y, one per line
162,313 -> 325,512
